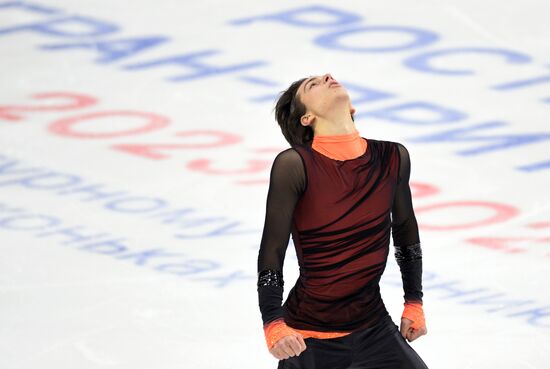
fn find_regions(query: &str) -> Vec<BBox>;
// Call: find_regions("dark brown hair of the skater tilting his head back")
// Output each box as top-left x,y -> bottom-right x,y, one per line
274,77 -> 353,146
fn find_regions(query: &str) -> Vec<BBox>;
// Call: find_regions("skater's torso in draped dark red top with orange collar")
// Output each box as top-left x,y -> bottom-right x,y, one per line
283,132 -> 399,338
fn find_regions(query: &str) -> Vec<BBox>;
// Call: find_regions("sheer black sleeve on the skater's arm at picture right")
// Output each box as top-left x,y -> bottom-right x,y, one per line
392,143 -> 423,302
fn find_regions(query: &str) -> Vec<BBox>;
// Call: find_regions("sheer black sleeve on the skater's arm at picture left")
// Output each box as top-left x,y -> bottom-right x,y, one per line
257,148 -> 307,325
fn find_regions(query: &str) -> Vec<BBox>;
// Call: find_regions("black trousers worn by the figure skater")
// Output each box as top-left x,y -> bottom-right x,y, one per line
277,315 -> 428,369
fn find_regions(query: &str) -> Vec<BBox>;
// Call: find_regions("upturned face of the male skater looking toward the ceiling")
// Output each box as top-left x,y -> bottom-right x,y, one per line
296,73 -> 355,126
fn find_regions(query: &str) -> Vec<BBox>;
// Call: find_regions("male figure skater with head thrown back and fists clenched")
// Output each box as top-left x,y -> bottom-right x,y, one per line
257,73 -> 427,369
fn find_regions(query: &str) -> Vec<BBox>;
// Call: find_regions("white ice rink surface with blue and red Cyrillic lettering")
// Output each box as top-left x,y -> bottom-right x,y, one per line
0,0 -> 550,369
